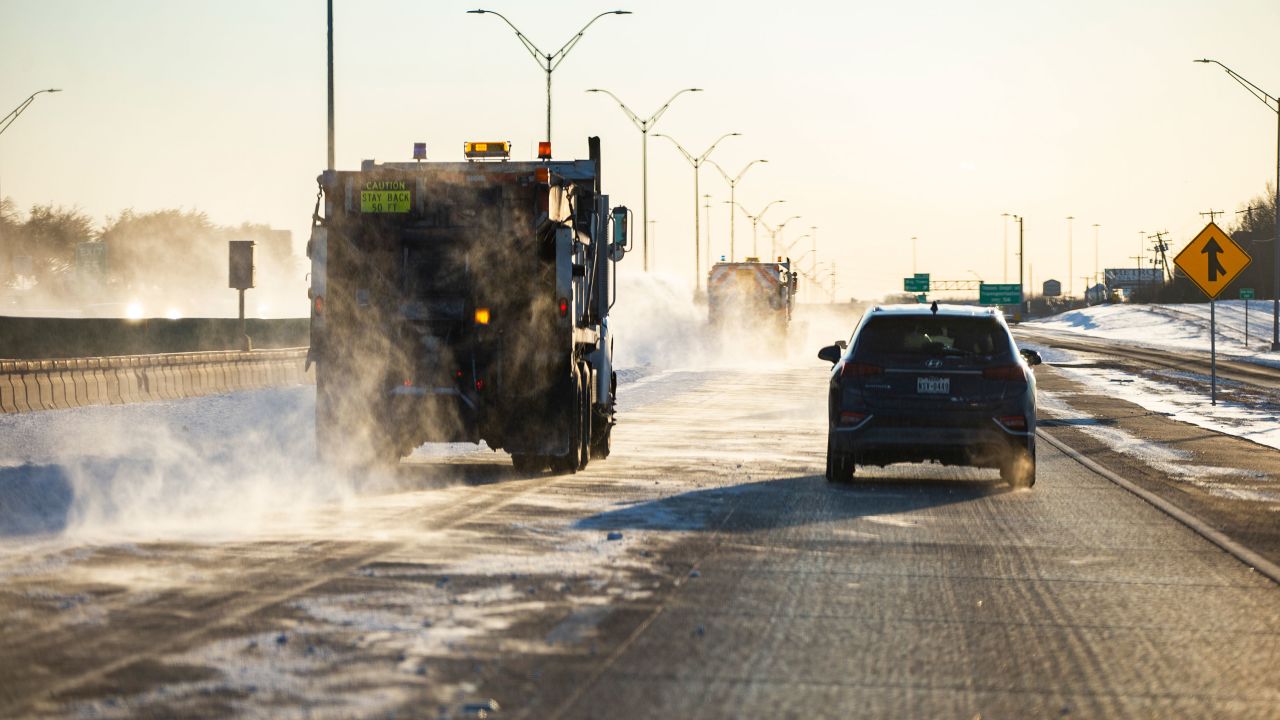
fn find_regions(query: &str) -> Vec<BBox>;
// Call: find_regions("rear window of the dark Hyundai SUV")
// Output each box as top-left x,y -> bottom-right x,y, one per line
856,315 -> 1009,356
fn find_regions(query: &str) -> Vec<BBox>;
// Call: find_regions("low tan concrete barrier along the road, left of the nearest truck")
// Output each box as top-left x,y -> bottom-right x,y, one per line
0,347 -> 315,413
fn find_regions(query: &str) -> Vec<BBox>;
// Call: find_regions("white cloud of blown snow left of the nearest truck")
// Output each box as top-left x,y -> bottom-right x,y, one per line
0,387 -> 353,539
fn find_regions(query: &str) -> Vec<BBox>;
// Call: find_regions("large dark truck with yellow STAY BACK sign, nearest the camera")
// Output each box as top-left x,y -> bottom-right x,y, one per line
308,138 -> 627,471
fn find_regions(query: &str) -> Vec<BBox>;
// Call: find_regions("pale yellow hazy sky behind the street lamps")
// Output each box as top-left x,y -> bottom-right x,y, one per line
0,0 -> 1280,304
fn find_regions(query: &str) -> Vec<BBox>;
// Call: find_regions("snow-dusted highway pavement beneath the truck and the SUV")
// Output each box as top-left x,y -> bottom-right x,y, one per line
0,351 -> 1280,717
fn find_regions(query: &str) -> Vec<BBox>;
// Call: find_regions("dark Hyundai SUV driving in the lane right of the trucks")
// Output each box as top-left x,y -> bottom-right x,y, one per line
818,302 -> 1041,487
